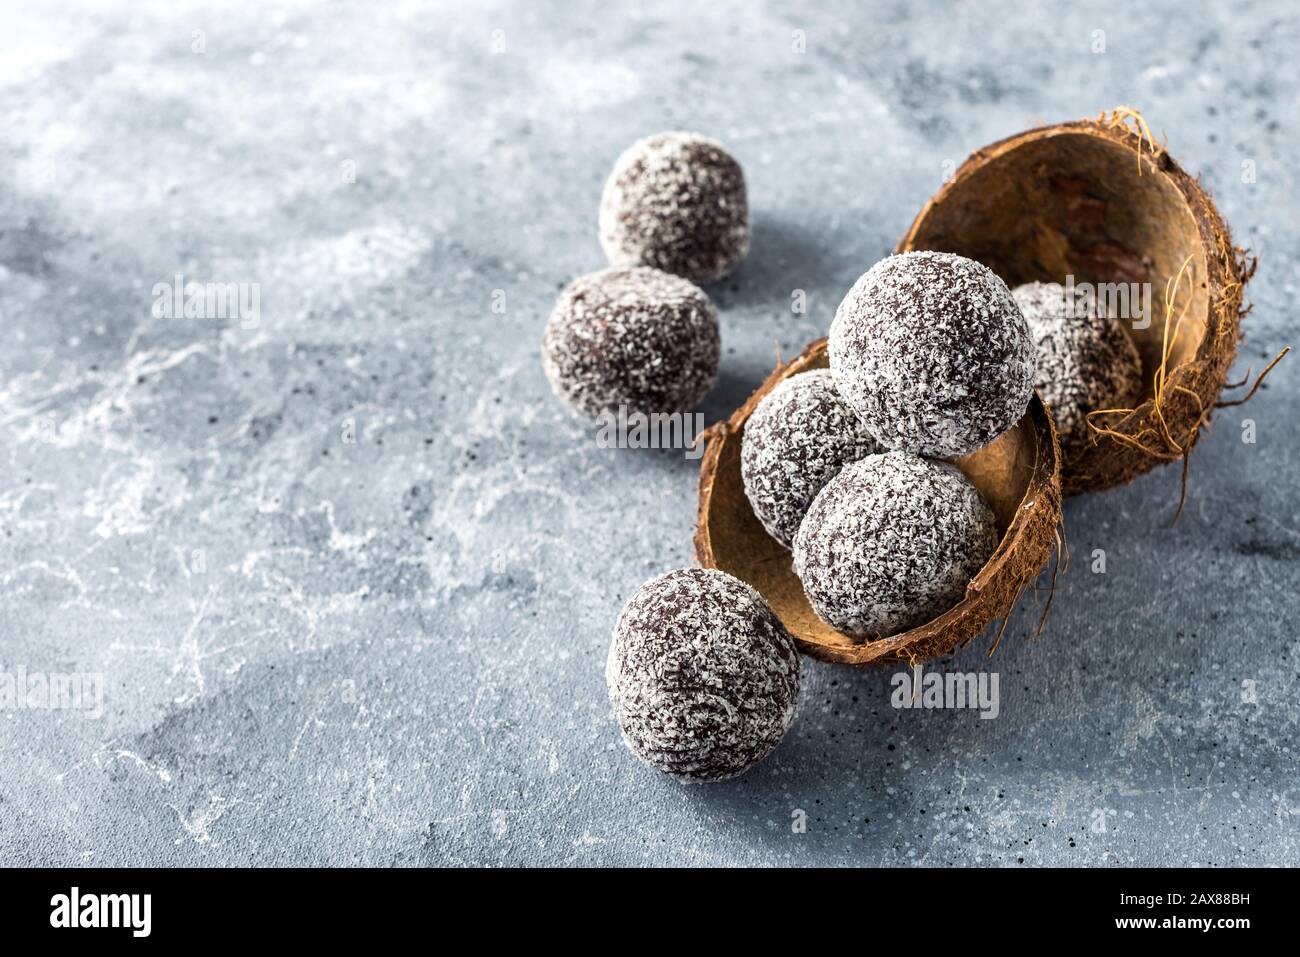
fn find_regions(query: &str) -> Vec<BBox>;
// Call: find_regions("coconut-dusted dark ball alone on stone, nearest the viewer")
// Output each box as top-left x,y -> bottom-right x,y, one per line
605,568 -> 800,781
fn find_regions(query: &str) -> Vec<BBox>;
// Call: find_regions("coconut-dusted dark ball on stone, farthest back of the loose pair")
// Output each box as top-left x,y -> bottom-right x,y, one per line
601,133 -> 749,282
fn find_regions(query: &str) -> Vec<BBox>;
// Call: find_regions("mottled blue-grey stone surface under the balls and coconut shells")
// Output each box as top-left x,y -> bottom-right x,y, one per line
0,0 -> 1300,866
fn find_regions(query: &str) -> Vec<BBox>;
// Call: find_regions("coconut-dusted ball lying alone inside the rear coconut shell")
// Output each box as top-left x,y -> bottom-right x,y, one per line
1011,282 -> 1143,455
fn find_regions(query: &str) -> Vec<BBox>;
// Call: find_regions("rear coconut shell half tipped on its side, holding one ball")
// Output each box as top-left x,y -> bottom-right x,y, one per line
898,108 -> 1255,495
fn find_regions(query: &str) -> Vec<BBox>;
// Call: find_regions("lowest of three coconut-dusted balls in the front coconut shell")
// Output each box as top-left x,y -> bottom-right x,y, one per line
794,451 -> 998,640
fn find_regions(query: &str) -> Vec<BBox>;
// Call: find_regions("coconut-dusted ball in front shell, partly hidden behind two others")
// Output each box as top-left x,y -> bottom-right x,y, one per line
740,369 -> 883,547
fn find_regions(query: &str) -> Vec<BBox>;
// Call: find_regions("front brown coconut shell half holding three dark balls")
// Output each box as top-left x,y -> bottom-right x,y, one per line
696,339 -> 1065,666
